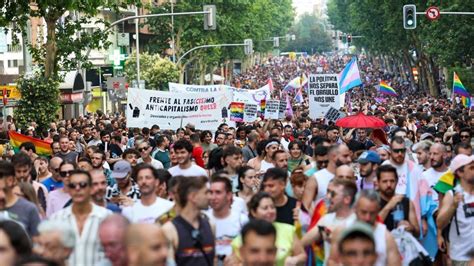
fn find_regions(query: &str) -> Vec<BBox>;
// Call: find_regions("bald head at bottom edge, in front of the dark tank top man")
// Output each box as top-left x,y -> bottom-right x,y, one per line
125,224 -> 169,266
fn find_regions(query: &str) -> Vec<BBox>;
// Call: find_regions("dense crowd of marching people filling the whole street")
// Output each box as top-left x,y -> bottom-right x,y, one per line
0,56 -> 474,266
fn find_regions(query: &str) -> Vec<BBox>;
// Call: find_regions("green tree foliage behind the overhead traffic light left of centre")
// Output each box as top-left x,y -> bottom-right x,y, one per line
146,0 -> 294,80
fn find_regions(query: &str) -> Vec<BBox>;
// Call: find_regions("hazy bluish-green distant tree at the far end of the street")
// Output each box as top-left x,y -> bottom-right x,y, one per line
286,14 -> 332,53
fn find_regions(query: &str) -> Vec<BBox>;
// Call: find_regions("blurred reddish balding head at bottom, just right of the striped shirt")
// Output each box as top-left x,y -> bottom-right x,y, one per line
99,214 -> 130,266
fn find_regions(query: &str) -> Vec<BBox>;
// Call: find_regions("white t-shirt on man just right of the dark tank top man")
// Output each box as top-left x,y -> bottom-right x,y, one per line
206,209 -> 249,256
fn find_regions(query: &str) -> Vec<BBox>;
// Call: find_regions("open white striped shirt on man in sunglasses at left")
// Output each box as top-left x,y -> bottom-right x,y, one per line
50,203 -> 112,266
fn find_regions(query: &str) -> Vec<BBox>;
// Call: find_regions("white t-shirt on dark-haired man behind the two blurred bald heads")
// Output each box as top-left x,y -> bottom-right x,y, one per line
122,197 -> 174,224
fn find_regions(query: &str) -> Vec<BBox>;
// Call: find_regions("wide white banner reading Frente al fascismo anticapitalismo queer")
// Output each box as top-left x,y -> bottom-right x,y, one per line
127,88 -> 228,130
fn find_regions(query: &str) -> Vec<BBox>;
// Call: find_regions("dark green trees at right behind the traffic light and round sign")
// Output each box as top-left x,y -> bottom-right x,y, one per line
328,0 -> 474,95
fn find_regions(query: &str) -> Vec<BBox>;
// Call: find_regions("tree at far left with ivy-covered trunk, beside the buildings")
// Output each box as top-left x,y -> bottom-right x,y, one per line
0,0 -> 140,129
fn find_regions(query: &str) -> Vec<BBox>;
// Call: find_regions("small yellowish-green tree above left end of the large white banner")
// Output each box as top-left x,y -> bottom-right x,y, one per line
124,53 -> 179,91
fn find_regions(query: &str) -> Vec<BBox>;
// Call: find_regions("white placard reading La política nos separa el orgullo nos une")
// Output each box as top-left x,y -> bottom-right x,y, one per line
308,74 -> 340,119
